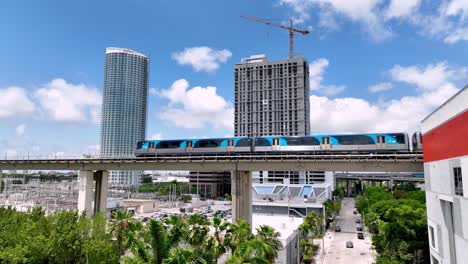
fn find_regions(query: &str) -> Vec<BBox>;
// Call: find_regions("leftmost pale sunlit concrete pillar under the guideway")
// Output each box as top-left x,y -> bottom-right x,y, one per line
78,170 -> 94,216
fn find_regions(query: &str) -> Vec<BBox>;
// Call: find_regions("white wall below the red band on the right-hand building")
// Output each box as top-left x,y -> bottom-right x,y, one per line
424,156 -> 468,264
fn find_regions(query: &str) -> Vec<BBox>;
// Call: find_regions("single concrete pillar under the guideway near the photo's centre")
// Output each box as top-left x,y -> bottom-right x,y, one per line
231,170 -> 252,226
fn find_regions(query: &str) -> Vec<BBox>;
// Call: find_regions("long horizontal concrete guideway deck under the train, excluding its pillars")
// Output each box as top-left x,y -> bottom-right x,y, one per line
0,152 -> 423,172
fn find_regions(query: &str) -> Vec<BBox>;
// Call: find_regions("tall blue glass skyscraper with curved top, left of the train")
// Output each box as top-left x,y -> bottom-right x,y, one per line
101,48 -> 149,185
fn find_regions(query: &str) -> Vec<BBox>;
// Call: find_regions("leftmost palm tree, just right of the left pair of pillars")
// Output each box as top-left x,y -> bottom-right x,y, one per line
110,210 -> 142,256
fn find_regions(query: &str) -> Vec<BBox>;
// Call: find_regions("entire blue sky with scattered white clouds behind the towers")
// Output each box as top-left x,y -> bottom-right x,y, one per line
0,0 -> 468,155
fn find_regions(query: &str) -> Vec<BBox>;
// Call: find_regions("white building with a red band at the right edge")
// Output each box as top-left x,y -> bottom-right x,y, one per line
422,86 -> 468,264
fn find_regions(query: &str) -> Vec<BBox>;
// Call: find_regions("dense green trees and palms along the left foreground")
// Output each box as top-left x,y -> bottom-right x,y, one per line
0,208 -> 282,264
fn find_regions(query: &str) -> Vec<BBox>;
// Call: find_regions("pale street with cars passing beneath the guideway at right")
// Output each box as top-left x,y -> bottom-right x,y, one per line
316,198 -> 375,264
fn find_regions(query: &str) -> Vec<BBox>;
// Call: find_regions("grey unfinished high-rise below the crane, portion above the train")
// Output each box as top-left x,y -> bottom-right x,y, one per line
234,55 -> 310,137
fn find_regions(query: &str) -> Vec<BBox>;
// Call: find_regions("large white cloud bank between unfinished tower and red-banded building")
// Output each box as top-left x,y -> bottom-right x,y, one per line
310,62 -> 466,133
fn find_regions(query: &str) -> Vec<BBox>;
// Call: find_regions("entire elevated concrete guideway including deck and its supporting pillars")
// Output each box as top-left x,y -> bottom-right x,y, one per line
0,152 -> 423,223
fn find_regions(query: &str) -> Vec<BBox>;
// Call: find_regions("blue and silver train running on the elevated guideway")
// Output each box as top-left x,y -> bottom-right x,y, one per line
135,133 -> 422,157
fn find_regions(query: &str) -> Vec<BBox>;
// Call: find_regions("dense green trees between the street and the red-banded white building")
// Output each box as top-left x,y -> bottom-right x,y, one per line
356,183 -> 429,264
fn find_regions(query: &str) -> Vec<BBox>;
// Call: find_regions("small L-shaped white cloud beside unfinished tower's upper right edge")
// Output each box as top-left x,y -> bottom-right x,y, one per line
309,58 -> 346,96
